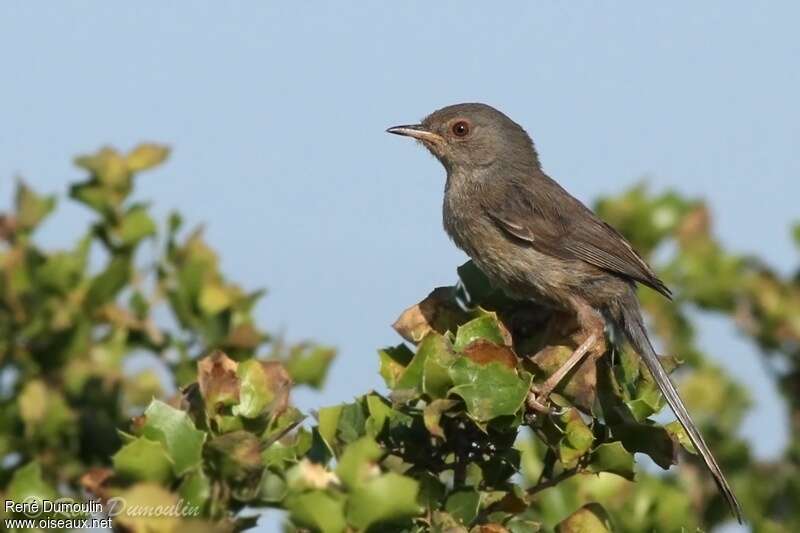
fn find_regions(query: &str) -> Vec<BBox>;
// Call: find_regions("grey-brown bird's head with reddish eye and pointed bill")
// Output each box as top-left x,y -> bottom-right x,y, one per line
386,103 -> 538,172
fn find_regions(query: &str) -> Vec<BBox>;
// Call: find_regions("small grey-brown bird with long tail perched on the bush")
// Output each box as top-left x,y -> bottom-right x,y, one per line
386,103 -> 743,523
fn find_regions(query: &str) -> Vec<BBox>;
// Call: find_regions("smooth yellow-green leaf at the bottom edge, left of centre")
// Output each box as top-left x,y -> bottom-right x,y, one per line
347,472 -> 421,530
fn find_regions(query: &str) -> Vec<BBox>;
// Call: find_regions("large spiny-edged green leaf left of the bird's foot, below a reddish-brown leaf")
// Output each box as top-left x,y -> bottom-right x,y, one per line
450,357 -> 531,422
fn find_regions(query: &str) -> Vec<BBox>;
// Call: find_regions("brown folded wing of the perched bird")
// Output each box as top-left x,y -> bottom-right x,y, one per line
483,176 -> 672,298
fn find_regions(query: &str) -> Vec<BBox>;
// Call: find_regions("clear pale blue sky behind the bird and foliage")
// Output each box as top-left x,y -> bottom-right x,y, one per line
0,1 -> 800,528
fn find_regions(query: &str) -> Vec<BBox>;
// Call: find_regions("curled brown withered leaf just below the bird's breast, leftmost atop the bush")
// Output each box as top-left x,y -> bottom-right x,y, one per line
392,287 -> 469,344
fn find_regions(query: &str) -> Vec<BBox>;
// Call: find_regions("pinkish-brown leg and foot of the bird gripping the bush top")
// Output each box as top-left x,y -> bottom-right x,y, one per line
527,298 -> 606,414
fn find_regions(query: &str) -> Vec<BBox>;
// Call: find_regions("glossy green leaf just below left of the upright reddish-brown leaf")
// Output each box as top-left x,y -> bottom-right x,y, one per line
143,400 -> 206,476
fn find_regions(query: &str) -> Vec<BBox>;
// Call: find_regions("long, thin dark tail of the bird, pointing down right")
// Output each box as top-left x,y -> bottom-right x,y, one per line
620,305 -> 742,524
